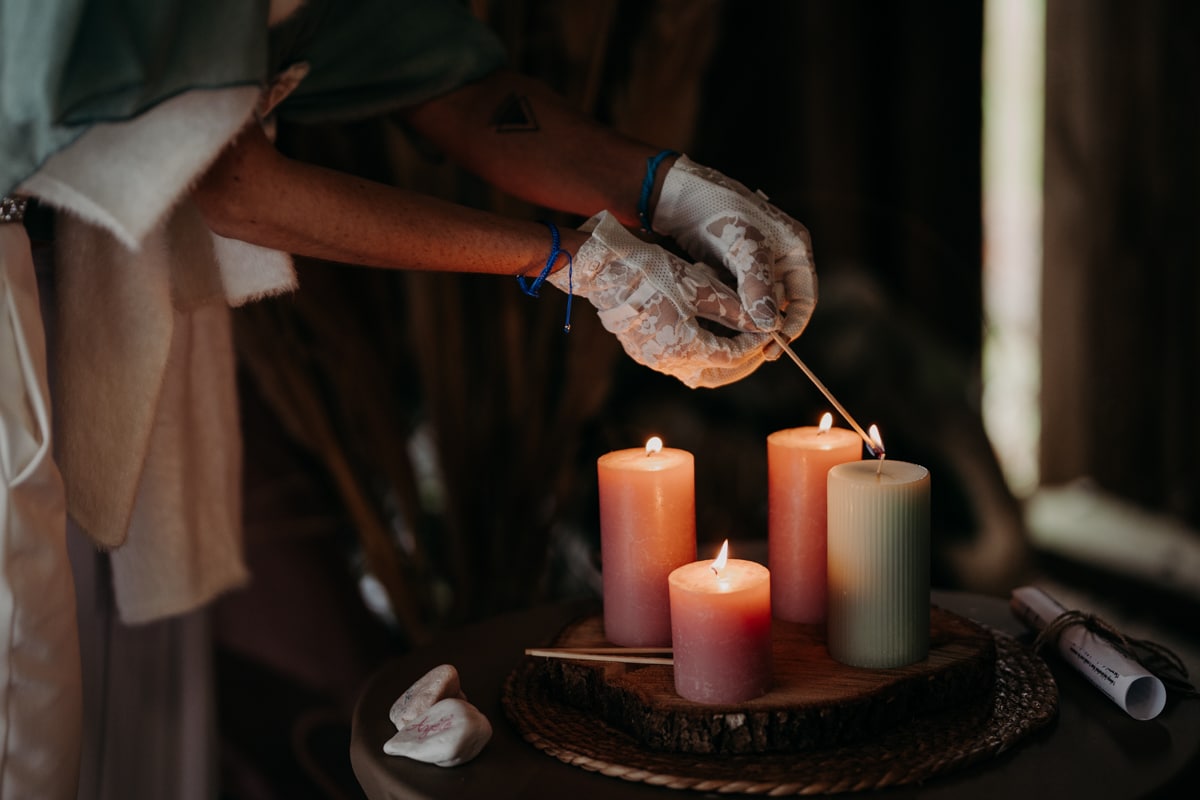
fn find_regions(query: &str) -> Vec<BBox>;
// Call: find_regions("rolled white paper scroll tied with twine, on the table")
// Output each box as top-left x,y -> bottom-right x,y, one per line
1009,587 -> 1166,721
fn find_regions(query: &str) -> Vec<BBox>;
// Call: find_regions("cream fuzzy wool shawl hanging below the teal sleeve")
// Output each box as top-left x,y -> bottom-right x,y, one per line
22,71 -> 295,624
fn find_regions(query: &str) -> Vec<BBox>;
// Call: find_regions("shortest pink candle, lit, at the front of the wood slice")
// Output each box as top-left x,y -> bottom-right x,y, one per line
670,542 -> 772,704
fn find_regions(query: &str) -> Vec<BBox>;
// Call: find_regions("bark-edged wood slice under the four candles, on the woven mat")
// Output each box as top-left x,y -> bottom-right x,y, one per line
516,608 -> 996,754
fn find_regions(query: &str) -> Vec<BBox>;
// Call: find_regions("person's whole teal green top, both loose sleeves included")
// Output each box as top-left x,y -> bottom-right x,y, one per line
0,0 -> 505,194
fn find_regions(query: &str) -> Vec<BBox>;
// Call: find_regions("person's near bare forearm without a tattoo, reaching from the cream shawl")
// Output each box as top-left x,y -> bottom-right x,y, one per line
194,126 -> 586,275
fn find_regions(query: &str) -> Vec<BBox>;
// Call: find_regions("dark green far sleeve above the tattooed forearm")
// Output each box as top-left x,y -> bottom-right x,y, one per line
271,0 -> 506,122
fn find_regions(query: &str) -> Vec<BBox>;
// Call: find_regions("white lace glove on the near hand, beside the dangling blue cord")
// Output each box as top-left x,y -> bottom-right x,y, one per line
547,211 -> 770,389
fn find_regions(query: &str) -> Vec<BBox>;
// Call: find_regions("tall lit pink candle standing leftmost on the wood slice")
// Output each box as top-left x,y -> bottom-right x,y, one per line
596,437 -> 696,648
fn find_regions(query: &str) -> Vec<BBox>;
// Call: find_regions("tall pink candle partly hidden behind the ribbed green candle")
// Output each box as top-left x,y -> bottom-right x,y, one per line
767,414 -> 863,624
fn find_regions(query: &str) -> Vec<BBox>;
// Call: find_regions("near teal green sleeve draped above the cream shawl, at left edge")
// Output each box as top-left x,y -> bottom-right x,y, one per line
0,0 -> 269,194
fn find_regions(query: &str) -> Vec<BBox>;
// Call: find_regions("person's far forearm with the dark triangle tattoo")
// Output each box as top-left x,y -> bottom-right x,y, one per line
404,71 -> 670,227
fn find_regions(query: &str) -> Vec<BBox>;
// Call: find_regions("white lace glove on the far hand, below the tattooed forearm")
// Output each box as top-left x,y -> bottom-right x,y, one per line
653,156 -> 817,347
